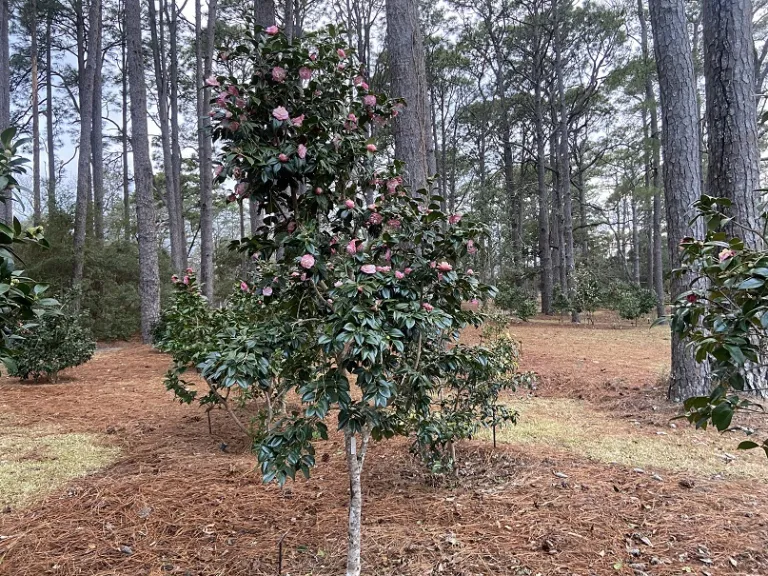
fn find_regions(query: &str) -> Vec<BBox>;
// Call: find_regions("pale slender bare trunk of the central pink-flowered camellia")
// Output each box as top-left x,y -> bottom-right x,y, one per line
344,429 -> 371,576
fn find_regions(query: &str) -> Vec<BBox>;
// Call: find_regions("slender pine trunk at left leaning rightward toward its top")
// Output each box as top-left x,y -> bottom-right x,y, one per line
72,0 -> 101,308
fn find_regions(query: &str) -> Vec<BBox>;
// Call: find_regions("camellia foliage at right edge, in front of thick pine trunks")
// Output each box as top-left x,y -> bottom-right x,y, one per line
671,196 -> 768,455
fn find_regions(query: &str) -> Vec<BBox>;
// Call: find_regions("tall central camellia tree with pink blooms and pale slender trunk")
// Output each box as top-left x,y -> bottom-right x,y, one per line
162,27 -> 519,575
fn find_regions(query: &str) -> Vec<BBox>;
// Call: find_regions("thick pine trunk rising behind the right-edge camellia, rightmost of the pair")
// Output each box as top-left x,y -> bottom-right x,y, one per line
703,0 -> 762,249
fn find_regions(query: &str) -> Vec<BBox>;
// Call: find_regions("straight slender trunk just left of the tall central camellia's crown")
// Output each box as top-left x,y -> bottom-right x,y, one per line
195,0 -> 217,302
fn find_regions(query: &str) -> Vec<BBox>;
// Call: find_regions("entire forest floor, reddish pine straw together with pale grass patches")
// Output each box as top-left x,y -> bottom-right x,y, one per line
0,315 -> 768,576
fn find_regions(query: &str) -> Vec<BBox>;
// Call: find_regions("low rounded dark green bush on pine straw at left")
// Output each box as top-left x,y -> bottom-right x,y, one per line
12,311 -> 96,382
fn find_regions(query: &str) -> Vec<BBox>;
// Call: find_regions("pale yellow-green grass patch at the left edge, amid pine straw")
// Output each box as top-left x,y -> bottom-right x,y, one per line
0,417 -> 119,508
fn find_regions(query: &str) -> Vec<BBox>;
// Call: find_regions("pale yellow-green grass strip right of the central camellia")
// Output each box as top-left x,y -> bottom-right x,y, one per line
488,398 -> 768,481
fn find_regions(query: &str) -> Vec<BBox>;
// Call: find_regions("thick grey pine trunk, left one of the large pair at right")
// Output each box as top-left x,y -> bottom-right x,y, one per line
649,0 -> 710,401
